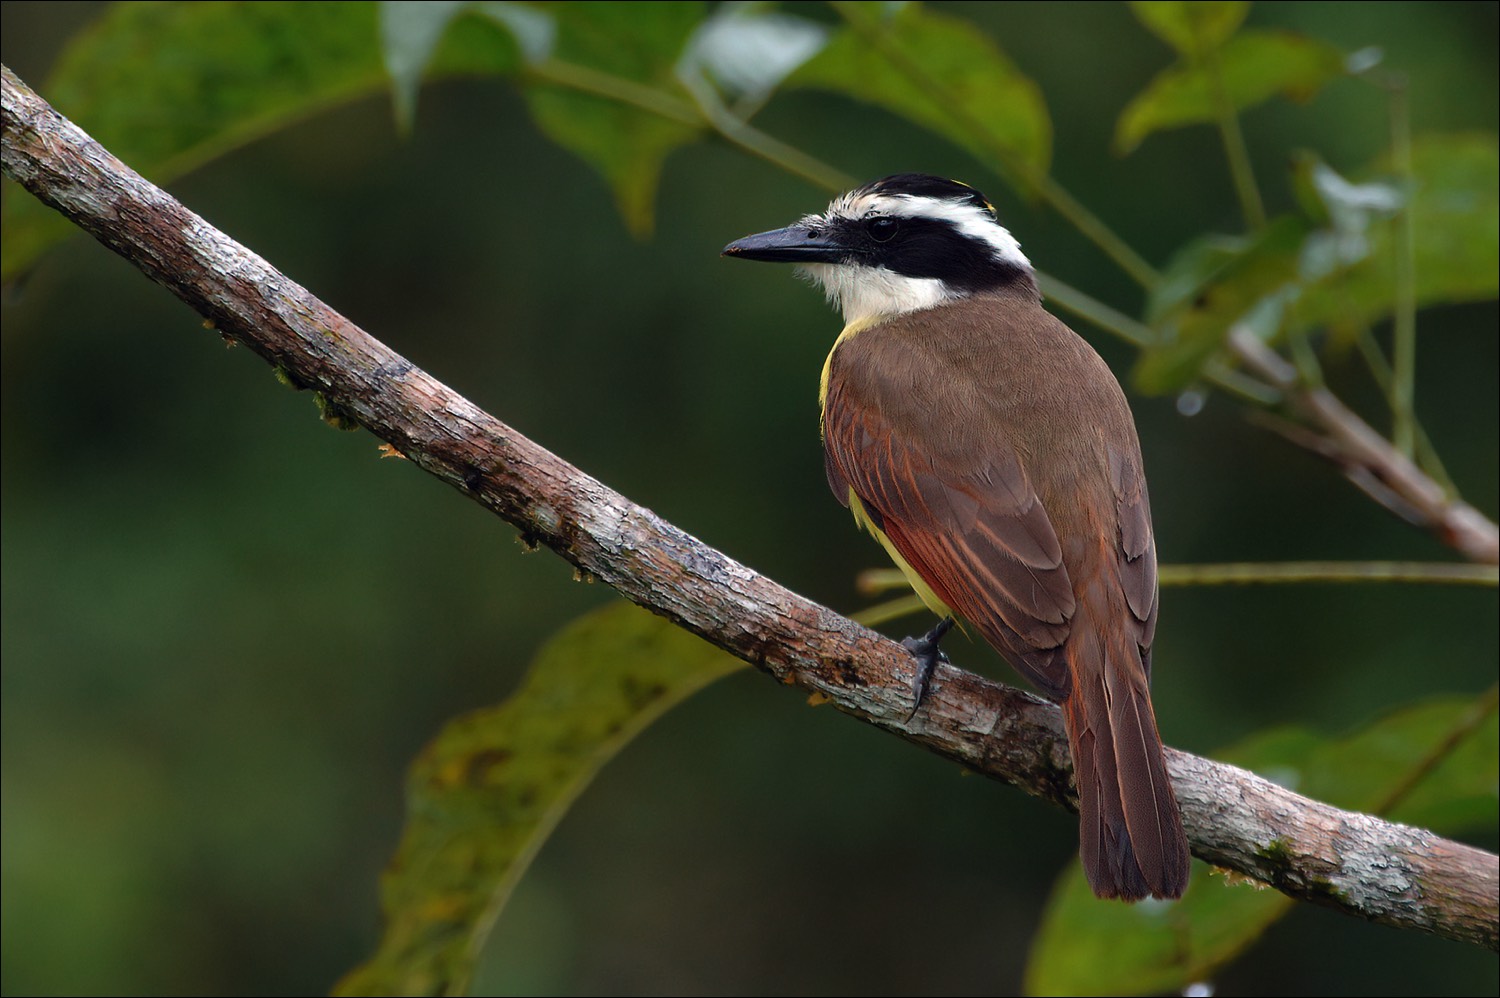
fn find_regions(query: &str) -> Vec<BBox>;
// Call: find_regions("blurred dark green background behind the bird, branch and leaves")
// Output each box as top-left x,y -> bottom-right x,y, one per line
0,3 -> 1500,995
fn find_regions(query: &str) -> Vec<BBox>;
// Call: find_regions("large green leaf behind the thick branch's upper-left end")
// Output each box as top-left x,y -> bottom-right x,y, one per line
0,3 -> 518,281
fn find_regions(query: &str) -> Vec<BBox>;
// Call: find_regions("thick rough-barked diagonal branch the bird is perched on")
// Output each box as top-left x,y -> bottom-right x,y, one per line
3,69 -> 1500,948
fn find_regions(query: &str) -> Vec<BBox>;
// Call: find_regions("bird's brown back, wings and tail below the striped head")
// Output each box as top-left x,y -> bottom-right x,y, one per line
824,279 -> 1188,900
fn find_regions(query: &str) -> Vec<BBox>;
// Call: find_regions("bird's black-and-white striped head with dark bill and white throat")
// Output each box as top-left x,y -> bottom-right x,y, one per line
723,173 -> 1037,323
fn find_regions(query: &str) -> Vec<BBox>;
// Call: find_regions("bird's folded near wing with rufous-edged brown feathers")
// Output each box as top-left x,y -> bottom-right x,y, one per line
824,361 -> 1074,698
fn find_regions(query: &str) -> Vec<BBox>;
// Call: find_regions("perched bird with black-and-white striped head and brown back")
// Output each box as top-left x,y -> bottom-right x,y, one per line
723,174 -> 1188,900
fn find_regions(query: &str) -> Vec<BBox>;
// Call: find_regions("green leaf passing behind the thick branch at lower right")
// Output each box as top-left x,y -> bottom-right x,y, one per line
1026,689 -> 1500,995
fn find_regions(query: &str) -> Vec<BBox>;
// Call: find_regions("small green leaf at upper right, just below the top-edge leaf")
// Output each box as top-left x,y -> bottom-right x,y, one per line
1115,30 -> 1347,155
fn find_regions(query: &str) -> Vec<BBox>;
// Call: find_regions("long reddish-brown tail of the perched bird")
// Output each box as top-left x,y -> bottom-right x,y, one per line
1062,635 -> 1188,900
